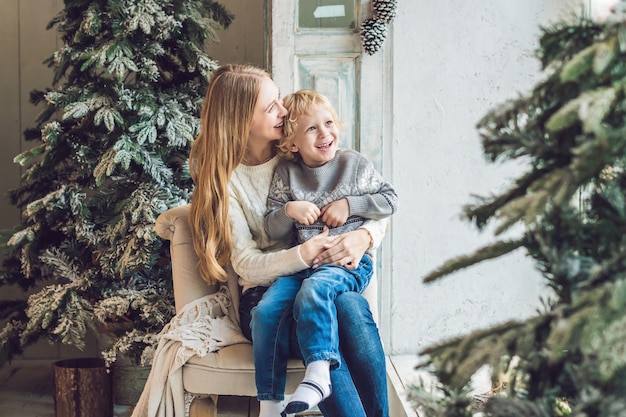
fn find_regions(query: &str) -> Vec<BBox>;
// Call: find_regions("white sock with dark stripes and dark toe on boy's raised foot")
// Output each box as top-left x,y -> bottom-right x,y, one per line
285,360 -> 332,414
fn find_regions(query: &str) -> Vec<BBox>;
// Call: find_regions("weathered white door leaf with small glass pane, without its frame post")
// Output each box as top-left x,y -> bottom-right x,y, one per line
271,0 -> 364,150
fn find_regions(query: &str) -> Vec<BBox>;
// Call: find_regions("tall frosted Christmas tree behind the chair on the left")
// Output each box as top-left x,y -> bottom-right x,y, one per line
0,0 -> 233,364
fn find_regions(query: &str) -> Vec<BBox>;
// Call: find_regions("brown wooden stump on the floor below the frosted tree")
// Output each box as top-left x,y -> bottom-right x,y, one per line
52,358 -> 113,417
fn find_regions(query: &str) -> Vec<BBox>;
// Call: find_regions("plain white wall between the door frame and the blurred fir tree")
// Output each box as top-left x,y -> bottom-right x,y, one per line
382,0 -> 582,354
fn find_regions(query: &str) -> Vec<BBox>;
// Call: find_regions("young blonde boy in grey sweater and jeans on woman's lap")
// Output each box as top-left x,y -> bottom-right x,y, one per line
251,90 -> 397,417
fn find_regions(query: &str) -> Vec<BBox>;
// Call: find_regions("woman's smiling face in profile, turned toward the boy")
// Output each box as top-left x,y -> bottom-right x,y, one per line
249,78 -> 287,142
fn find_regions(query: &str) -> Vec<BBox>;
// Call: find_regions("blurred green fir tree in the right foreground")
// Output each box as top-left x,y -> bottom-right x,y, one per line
412,10 -> 626,417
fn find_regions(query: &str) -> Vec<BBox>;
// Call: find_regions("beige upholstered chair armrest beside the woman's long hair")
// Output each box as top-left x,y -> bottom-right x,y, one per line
155,205 -> 219,313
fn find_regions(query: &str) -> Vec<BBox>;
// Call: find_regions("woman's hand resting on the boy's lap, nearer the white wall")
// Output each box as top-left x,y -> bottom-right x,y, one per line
309,229 -> 371,270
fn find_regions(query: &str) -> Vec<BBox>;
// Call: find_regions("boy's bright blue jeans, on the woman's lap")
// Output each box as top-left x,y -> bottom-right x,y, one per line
250,255 -> 373,400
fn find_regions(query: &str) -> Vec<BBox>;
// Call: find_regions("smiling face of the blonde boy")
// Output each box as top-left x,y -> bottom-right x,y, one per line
290,105 -> 339,168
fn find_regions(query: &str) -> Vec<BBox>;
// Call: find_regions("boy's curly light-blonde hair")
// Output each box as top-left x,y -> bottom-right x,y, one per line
278,89 -> 342,159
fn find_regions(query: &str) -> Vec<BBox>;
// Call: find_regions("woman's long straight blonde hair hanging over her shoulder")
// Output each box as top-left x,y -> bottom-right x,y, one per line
189,65 -> 269,284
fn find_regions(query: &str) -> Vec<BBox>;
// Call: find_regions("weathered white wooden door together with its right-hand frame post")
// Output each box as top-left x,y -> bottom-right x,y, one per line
270,0 -> 389,164
